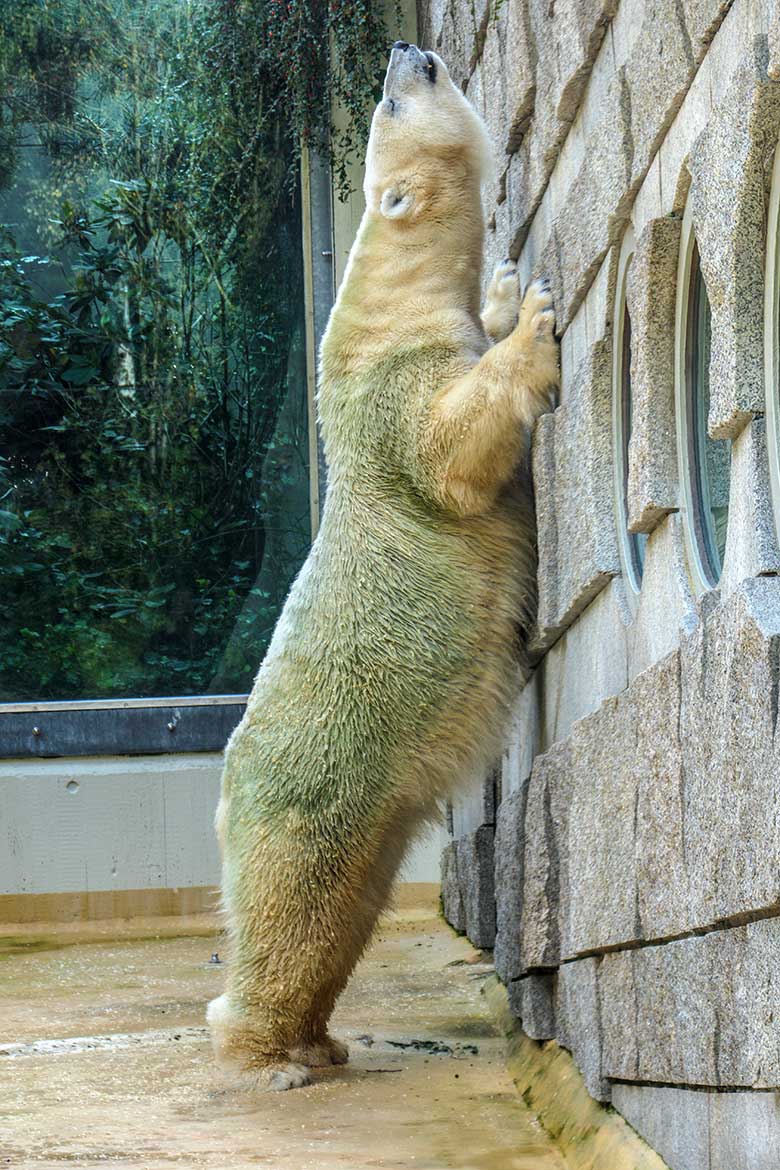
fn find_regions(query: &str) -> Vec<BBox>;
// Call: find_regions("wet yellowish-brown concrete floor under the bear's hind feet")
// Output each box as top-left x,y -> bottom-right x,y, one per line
0,907 -> 573,1170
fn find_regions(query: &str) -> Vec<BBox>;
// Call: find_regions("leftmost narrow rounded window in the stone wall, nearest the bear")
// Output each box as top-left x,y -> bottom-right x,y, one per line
613,236 -> 647,594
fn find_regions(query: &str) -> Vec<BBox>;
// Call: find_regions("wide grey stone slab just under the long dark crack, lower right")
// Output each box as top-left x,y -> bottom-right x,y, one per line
599,918 -> 780,1088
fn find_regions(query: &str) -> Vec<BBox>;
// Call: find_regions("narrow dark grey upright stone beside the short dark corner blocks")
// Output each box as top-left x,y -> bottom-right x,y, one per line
493,785 -> 527,983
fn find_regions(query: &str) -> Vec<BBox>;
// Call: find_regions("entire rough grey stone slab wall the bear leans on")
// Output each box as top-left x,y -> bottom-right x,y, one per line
428,0 -> 780,1170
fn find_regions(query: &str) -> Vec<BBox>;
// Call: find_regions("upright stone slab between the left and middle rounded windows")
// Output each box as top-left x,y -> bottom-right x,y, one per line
626,216 -> 681,532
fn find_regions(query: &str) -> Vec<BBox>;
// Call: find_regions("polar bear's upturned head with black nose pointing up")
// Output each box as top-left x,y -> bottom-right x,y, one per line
365,41 -> 491,227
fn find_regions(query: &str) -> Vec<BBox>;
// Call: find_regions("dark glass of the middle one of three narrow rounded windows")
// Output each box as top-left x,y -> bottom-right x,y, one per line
688,253 -> 731,585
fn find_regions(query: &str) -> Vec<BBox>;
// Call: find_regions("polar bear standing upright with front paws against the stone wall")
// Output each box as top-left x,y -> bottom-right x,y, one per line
208,42 -> 558,1089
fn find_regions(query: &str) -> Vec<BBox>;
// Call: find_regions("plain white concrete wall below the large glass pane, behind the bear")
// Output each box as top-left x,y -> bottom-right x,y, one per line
0,752 -> 443,895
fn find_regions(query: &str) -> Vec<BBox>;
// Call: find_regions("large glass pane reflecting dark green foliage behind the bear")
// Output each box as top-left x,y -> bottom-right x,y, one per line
0,0 -> 311,701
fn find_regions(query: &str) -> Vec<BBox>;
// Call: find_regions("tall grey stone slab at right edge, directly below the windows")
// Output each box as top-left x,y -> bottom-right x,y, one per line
679,578 -> 780,929
